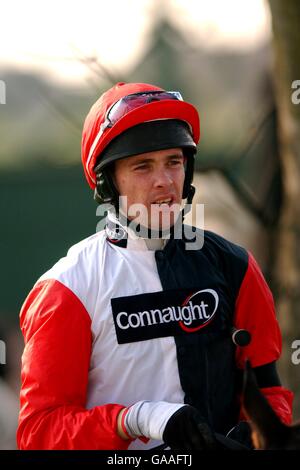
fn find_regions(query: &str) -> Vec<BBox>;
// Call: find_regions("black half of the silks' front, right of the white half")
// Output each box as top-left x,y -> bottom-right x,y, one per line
155,227 -> 248,433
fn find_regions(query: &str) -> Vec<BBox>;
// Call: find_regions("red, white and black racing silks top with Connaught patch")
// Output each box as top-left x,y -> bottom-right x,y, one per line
17,217 -> 291,449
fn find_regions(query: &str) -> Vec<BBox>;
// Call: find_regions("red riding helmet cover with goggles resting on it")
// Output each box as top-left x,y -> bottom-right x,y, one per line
81,83 -> 200,189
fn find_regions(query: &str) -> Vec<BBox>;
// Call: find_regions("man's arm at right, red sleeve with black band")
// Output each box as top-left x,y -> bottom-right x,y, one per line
234,254 -> 293,423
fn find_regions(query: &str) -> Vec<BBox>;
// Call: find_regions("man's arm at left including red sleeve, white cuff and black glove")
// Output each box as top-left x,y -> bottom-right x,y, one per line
17,280 -> 225,450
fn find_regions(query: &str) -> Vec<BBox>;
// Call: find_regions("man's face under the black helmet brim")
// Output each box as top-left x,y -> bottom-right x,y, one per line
114,148 -> 185,230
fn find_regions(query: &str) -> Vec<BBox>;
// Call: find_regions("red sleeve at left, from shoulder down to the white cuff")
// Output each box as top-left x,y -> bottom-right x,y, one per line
17,280 -> 131,450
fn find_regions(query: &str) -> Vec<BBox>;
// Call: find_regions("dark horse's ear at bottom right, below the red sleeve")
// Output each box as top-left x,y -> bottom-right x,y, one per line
243,360 -> 288,449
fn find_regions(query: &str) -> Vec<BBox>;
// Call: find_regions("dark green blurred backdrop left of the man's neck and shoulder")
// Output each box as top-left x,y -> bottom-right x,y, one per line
0,165 -> 98,320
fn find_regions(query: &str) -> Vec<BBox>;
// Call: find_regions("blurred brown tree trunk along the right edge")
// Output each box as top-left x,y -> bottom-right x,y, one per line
269,0 -> 300,419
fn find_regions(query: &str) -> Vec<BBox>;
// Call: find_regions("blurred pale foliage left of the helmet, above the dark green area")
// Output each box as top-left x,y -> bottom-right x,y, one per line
0,72 -> 93,169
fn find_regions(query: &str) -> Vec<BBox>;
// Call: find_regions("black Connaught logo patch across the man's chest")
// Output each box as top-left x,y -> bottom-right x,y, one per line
111,289 -> 219,344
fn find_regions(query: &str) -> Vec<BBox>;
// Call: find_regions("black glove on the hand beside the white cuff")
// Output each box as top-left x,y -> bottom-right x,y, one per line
163,405 -> 216,451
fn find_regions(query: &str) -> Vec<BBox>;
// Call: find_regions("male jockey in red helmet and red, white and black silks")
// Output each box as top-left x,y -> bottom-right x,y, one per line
18,83 -> 292,450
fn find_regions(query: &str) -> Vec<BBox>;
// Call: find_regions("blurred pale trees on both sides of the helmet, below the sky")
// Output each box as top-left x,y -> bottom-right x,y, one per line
0,20 -> 273,171
